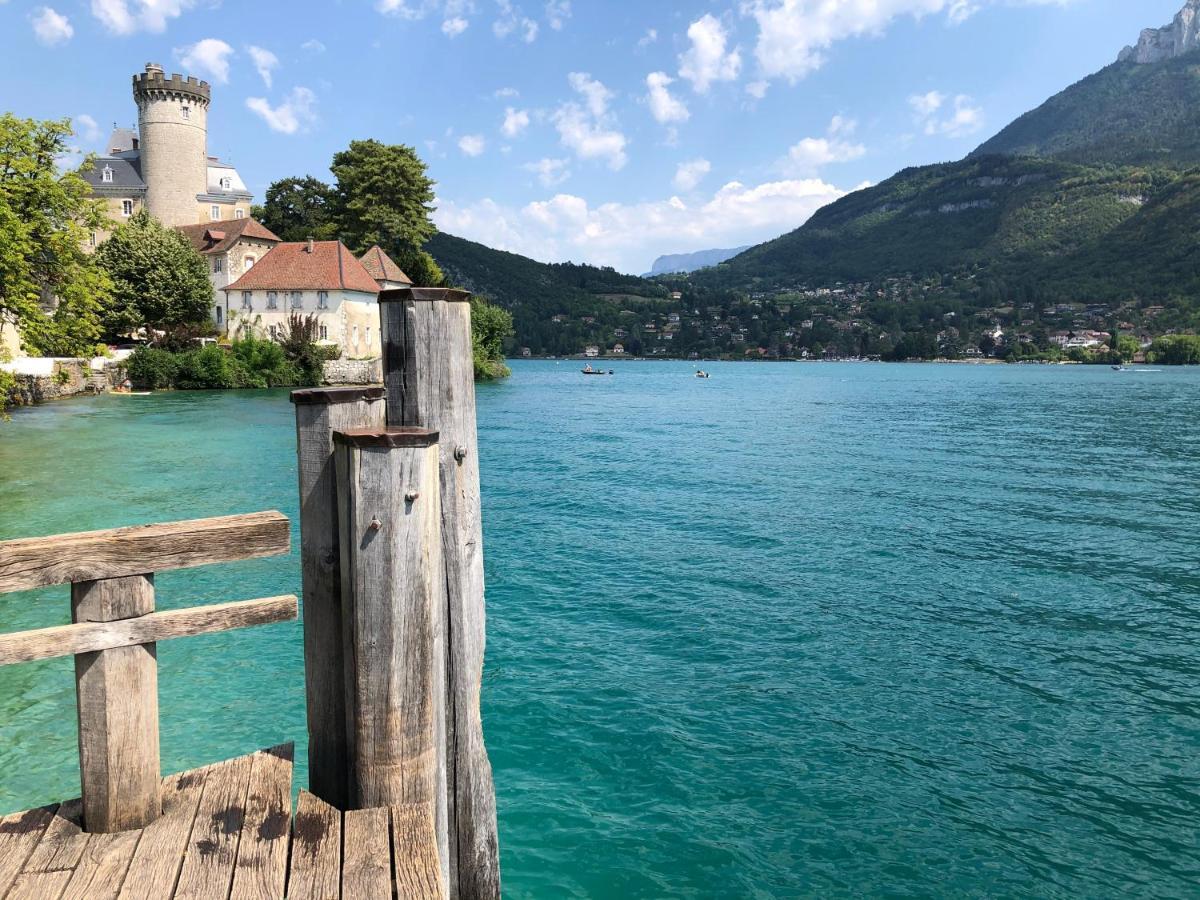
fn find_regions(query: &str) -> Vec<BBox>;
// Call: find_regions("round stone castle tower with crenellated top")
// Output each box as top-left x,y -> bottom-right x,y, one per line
133,62 -> 210,227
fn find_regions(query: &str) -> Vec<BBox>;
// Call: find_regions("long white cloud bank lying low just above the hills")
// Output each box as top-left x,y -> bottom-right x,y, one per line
434,179 -> 846,272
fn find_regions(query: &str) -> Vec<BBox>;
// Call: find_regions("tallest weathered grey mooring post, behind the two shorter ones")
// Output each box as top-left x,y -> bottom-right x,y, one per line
379,288 -> 500,900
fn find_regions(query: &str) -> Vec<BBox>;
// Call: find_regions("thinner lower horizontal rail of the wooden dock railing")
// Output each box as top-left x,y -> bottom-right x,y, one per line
0,594 -> 299,666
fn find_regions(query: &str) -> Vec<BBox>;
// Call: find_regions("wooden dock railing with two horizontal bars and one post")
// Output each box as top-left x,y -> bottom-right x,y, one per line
0,512 -> 296,834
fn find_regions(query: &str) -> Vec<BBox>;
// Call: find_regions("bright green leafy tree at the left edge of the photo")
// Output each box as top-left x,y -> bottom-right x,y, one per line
0,113 -> 110,356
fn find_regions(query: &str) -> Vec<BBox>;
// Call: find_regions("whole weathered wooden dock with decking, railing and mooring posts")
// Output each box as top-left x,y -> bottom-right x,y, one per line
0,290 -> 500,900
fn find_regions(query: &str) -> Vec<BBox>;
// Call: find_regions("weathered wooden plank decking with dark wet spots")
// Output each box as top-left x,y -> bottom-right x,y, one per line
0,744 -> 445,900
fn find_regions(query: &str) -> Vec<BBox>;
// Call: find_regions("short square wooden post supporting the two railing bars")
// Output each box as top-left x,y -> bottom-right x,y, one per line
71,575 -> 162,834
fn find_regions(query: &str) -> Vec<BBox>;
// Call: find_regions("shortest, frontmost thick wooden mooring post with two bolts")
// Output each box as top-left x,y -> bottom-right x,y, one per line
334,428 -> 445,810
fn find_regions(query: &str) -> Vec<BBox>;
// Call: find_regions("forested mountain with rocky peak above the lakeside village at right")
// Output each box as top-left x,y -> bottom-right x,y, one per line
691,0 -> 1200,305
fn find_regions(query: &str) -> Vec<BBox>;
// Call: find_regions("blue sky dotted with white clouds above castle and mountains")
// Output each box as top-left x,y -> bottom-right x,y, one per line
0,0 -> 1182,272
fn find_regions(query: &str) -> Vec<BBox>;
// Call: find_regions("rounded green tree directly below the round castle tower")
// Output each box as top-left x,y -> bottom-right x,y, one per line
96,209 -> 212,335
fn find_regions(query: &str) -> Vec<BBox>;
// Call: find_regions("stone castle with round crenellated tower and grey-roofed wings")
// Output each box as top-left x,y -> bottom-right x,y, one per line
83,62 -> 253,236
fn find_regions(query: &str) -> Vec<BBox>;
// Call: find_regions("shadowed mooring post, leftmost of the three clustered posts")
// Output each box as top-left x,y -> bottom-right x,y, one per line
292,388 -> 384,810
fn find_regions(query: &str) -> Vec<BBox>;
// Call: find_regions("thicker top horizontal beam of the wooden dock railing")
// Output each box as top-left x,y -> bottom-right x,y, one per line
0,512 -> 289,594
